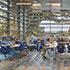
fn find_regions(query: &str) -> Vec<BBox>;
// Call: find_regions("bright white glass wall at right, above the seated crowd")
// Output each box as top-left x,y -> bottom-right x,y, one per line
39,11 -> 70,33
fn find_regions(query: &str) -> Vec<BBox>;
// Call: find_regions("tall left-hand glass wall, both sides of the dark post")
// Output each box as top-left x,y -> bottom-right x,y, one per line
0,0 -> 19,36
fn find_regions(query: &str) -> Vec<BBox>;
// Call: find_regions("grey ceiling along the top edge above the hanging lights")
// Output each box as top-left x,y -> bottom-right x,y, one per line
15,0 -> 70,10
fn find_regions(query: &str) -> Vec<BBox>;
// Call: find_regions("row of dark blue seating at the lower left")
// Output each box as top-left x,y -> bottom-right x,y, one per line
0,42 -> 27,60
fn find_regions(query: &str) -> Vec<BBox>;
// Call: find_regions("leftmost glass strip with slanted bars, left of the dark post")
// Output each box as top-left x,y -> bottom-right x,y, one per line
0,0 -> 7,36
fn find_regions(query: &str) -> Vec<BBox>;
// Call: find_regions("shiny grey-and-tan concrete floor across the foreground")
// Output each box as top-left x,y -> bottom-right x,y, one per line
0,51 -> 70,70
